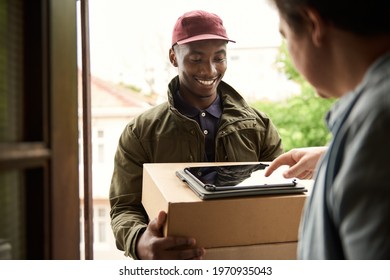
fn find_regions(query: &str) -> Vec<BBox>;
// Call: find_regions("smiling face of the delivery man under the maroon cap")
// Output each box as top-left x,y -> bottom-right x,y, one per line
169,40 -> 227,109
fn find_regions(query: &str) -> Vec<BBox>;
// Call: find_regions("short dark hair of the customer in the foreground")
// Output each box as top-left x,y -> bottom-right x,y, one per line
269,0 -> 390,36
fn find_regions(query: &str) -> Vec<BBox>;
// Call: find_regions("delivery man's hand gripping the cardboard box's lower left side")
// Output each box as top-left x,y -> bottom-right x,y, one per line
136,211 -> 205,260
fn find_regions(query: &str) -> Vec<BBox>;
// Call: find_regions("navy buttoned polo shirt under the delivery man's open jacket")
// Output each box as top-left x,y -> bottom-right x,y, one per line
173,91 -> 222,161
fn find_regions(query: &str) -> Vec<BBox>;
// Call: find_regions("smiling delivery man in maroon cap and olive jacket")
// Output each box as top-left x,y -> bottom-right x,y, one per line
110,11 -> 283,259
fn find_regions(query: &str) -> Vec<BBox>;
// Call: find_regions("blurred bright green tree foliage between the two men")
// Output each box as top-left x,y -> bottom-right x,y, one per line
252,40 -> 334,151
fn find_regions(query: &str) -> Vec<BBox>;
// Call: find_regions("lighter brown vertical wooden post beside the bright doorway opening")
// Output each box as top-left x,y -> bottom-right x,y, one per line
48,0 -> 80,259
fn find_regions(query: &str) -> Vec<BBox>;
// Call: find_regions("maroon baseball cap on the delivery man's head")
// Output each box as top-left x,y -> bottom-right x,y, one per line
172,10 -> 235,46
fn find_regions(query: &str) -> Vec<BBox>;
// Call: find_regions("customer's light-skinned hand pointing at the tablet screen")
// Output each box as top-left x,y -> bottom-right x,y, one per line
265,147 -> 327,179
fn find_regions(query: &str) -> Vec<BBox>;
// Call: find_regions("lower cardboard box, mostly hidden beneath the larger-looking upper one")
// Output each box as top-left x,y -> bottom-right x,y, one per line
204,242 -> 298,260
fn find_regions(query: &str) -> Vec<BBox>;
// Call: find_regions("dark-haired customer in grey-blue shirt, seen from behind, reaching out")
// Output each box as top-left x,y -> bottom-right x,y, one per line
267,0 -> 390,259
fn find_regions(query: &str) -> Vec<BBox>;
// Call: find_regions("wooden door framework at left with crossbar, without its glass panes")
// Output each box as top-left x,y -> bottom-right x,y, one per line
0,0 -> 80,259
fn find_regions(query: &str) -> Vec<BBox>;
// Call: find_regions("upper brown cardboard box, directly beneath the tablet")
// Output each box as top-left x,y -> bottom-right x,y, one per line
142,163 -> 307,249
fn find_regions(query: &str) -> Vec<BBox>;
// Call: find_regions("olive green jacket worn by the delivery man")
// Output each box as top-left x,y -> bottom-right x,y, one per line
109,77 -> 283,259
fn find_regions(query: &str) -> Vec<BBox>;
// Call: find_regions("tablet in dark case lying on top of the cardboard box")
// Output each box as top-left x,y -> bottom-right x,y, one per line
176,163 -> 307,200
